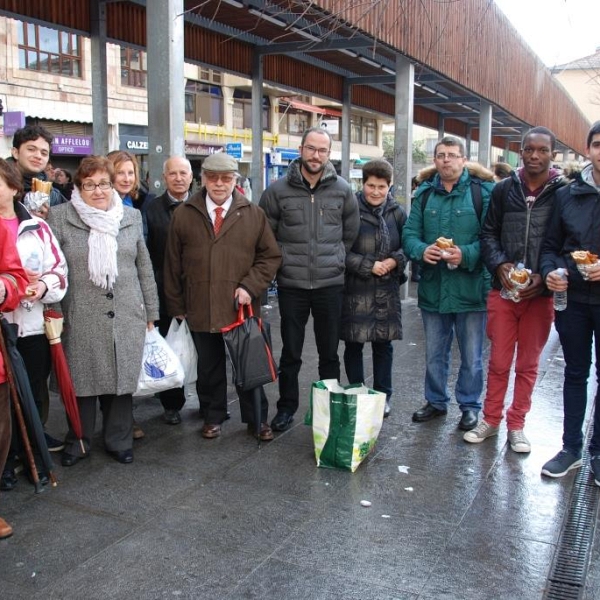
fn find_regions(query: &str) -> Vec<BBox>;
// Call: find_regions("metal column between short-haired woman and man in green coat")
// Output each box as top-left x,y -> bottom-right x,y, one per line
394,56 -> 415,211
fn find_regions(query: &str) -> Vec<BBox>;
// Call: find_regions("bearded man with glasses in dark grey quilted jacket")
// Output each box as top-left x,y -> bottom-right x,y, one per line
260,127 -> 360,431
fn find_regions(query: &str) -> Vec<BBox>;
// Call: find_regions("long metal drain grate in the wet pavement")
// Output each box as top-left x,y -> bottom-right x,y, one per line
544,418 -> 599,600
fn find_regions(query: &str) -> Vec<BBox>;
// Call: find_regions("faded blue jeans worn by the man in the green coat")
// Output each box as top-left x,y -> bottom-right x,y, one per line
421,310 -> 487,412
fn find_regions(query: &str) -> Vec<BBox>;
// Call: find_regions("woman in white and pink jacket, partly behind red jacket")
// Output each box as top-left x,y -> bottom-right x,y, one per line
0,159 -> 67,491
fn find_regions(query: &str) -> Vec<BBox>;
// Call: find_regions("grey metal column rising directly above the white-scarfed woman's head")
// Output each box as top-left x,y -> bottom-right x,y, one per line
90,0 -> 108,154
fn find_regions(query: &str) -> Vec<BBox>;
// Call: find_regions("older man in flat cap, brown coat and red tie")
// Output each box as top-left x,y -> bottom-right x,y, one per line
164,153 -> 281,441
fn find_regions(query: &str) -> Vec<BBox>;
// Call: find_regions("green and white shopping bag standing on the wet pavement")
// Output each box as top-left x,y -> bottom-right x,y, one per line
304,379 -> 385,473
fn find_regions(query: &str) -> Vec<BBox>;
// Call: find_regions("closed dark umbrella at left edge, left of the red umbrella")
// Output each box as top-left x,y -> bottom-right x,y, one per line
0,319 -> 56,493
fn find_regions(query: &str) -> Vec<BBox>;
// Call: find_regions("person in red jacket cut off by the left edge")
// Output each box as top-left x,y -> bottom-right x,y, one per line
0,195 -> 28,540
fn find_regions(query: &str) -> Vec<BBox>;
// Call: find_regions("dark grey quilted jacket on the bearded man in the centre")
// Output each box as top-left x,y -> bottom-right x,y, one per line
260,158 -> 360,289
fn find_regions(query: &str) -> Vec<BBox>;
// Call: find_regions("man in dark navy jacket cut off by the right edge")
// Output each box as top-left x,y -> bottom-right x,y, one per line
540,121 -> 600,486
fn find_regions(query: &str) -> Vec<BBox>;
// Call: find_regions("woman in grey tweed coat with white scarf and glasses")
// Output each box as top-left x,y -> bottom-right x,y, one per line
48,156 -> 158,467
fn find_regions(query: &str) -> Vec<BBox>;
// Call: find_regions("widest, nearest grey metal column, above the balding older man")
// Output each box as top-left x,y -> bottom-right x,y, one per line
146,0 -> 185,193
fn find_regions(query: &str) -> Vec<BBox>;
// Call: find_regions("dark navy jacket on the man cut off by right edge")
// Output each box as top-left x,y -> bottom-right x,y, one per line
540,167 -> 600,304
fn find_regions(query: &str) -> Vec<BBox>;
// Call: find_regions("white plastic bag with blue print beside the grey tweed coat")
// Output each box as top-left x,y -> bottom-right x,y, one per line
134,329 -> 184,396
